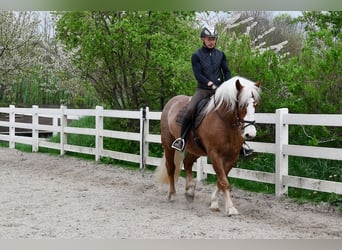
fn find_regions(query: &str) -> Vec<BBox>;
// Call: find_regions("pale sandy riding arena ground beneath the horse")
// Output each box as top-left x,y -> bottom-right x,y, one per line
0,148 -> 342,239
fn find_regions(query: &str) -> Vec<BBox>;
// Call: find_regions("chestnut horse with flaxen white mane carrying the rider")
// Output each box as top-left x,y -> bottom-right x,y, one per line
155,76 -> 261,216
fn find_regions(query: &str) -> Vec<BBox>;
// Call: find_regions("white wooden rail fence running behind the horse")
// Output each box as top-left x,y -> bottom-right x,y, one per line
0,105 -> 342,196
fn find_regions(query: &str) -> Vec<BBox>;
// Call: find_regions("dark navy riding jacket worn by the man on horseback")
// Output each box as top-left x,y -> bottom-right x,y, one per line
191,46 -> 231,89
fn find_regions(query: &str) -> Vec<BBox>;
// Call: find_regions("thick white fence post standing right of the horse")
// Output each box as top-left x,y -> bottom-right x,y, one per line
275,108 -> 289,196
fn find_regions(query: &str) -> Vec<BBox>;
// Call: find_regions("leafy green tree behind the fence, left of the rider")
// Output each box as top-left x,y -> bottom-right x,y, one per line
56,11 -> 194,109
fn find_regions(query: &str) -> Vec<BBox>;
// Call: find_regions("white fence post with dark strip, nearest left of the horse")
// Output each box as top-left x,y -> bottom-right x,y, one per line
140,107 -> 150,169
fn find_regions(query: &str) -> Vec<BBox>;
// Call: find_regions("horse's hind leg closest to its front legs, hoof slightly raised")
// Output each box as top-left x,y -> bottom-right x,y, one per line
183,153 -> 199,201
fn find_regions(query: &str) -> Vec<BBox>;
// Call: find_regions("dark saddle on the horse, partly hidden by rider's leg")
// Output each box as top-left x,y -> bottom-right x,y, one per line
176,96 -> 210,152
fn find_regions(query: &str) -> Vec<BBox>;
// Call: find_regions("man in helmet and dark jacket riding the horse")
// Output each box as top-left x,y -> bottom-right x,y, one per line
171,27 -> 253,155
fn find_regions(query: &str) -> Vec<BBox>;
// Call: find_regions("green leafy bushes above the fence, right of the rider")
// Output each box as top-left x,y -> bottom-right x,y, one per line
218,13 -> 342,116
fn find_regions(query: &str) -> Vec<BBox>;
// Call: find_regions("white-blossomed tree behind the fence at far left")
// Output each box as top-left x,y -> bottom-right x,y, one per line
0,11 -> 93,106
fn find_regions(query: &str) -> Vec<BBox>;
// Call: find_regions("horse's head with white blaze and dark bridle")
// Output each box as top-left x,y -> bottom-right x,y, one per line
235,77 -> 261,140
